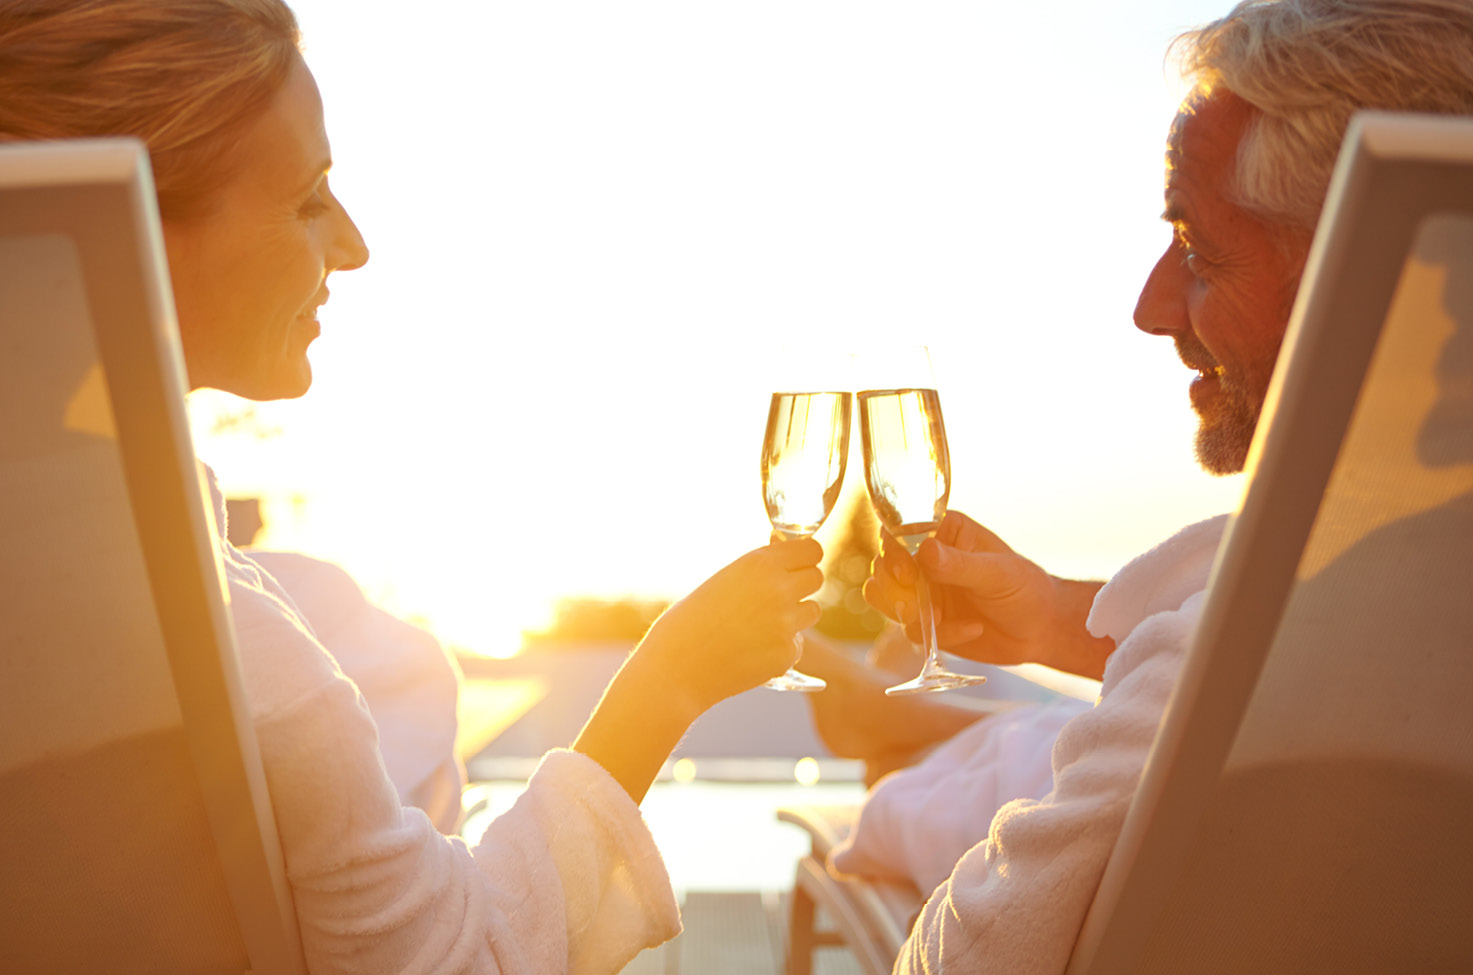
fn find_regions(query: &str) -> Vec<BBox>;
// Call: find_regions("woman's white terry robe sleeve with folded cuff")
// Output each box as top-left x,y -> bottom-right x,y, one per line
206,468 -> 681,975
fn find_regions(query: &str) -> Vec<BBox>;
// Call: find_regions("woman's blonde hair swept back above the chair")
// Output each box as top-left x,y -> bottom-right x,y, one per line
0,0 -> 300,218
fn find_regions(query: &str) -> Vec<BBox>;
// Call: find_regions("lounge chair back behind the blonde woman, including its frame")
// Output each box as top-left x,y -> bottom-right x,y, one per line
0,140 -> 305,974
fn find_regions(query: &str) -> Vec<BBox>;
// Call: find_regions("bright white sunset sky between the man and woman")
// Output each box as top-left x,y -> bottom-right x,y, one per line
184,0 -> 1240,652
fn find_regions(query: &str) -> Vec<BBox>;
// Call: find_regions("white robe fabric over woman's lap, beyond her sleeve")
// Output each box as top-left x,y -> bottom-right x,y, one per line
243,549 -> 465,834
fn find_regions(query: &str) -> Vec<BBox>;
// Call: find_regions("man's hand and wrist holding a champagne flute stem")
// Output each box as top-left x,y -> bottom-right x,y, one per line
865,511 -> 1115,677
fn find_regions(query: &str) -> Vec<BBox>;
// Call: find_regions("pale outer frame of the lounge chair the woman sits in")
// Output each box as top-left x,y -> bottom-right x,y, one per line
0,138 -> 306,975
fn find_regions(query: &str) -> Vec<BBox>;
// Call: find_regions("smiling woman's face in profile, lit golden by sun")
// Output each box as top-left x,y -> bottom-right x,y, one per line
164,60 -> 368,399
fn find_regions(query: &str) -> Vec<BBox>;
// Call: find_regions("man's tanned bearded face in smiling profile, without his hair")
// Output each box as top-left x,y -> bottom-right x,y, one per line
1136,88 -> 1304,474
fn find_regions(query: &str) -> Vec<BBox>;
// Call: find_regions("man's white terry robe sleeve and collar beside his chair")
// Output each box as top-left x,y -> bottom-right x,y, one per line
896,515 -> 1227,975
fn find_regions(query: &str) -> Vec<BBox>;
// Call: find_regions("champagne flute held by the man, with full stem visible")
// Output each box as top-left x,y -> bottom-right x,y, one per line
859,389 -> 987,694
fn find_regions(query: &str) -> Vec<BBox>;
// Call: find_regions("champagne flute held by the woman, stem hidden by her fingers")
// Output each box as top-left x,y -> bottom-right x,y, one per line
762,393 -> 850,691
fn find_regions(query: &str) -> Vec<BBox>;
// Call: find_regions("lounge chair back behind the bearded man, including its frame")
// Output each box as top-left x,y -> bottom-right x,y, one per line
1068,113 -> 1473,975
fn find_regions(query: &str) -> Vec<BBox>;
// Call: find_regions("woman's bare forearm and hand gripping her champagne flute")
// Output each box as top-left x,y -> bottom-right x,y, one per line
573,539 -> 823,803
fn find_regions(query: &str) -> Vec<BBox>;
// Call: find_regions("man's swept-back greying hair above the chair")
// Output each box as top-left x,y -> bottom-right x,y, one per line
1173,0 -> 1473,233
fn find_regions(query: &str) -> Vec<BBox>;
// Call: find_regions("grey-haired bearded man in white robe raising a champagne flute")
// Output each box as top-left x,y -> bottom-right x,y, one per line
824,0 -> 1473,972
